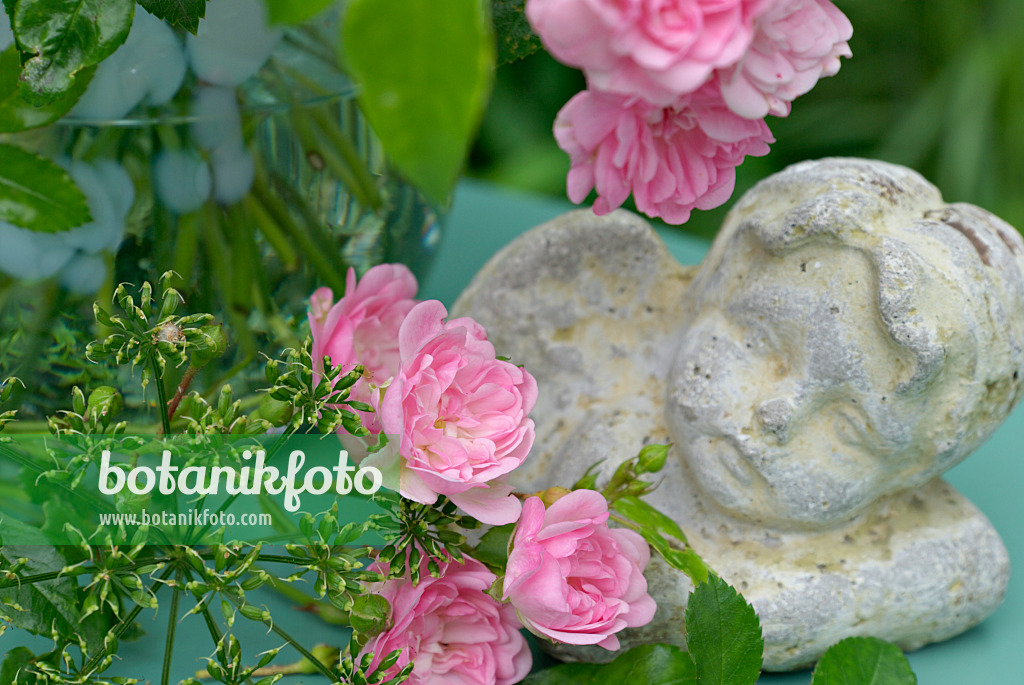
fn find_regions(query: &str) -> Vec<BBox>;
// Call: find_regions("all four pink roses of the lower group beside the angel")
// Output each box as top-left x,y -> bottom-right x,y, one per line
309,264 -> 655,685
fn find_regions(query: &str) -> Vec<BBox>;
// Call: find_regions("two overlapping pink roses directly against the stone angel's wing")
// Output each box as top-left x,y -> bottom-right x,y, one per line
309,264 -> 537,525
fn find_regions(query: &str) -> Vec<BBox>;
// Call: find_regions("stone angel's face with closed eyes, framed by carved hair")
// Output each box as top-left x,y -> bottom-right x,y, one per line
669,233 -> 933,526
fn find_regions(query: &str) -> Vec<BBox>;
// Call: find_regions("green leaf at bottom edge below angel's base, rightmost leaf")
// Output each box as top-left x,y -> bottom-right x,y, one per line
811,638 -> 918,685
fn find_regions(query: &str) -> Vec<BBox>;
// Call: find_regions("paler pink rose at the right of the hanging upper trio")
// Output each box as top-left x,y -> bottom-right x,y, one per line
717,0 -> 853,119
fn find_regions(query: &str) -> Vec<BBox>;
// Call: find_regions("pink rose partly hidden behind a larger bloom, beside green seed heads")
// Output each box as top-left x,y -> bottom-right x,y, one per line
309,264 -> 417,433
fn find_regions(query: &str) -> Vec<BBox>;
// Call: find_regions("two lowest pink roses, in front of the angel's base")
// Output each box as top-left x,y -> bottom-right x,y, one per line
364,490 -> 656,685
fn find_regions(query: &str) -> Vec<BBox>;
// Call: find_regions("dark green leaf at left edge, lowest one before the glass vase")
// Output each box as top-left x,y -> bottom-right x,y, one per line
0,143 -> 92,233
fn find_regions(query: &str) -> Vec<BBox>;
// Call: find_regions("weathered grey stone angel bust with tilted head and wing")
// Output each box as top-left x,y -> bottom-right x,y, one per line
455,160 -> 1024,670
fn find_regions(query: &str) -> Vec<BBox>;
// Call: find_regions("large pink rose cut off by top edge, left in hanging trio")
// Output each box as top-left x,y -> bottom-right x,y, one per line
526,0 -> 771,105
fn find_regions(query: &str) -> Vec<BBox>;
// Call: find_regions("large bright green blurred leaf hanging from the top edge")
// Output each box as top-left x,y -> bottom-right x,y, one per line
344,0 -> 495,203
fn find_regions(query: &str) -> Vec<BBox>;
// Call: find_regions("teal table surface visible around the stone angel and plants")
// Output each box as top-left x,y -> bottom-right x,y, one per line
0,182 -> 1024,685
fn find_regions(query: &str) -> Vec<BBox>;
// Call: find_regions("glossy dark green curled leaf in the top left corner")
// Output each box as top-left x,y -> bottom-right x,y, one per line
11,0 -> 135,104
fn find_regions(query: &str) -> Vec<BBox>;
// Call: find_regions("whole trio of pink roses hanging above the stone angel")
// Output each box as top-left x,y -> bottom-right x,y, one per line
526,0 -> 853,223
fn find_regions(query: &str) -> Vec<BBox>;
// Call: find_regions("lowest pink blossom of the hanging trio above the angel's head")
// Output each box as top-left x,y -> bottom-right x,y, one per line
555,84 -> 774,223
